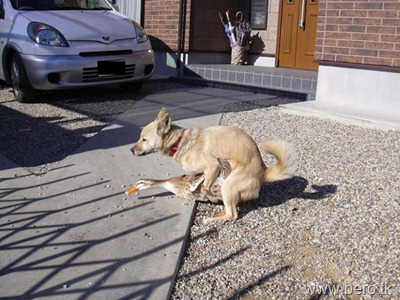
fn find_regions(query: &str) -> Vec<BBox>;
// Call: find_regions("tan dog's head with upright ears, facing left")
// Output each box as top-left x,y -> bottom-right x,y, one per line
131,107 -> 171,155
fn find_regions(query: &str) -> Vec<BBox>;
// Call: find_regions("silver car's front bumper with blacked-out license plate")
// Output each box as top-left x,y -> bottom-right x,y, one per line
21,50 -> 154,90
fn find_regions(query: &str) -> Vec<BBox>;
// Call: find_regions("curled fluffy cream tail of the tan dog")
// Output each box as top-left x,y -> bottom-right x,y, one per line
261,140 -> 296,182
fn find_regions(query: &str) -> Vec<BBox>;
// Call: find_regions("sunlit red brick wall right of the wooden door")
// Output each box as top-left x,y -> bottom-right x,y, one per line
315,0 -> 400,67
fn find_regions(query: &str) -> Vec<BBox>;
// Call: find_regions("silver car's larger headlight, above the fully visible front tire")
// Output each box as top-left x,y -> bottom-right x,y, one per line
28,22 -> 69,47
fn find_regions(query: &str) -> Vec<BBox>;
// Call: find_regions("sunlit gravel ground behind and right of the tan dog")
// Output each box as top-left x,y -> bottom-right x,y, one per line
171,102 -> 400,299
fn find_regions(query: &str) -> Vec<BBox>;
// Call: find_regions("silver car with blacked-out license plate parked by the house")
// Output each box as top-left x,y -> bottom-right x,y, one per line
0,0 -> 154,102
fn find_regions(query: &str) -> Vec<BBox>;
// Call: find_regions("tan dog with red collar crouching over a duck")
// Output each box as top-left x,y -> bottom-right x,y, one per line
131,108 -> 295,224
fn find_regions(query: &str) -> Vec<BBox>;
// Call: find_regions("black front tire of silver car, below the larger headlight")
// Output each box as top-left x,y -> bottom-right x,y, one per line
10,53 -> 35,103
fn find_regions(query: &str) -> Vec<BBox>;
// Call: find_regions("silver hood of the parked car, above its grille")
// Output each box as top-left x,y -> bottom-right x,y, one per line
21,10 -> 136,43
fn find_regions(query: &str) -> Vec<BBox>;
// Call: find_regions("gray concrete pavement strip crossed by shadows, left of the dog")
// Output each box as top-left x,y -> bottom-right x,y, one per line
0,88 -> 268,300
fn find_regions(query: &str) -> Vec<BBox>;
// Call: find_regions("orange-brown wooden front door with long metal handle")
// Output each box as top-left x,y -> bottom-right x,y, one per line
278,0 -> 318,70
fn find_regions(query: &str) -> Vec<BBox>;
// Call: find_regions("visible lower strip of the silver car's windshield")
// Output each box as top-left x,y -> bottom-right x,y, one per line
11,0 -> 112,10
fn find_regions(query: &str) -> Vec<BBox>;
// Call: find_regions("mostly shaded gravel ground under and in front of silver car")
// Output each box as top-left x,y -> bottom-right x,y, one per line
0,79 -> 195,175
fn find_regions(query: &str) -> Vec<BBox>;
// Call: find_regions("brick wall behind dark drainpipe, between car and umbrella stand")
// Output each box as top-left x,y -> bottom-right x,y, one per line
143,0 -> 248,52
